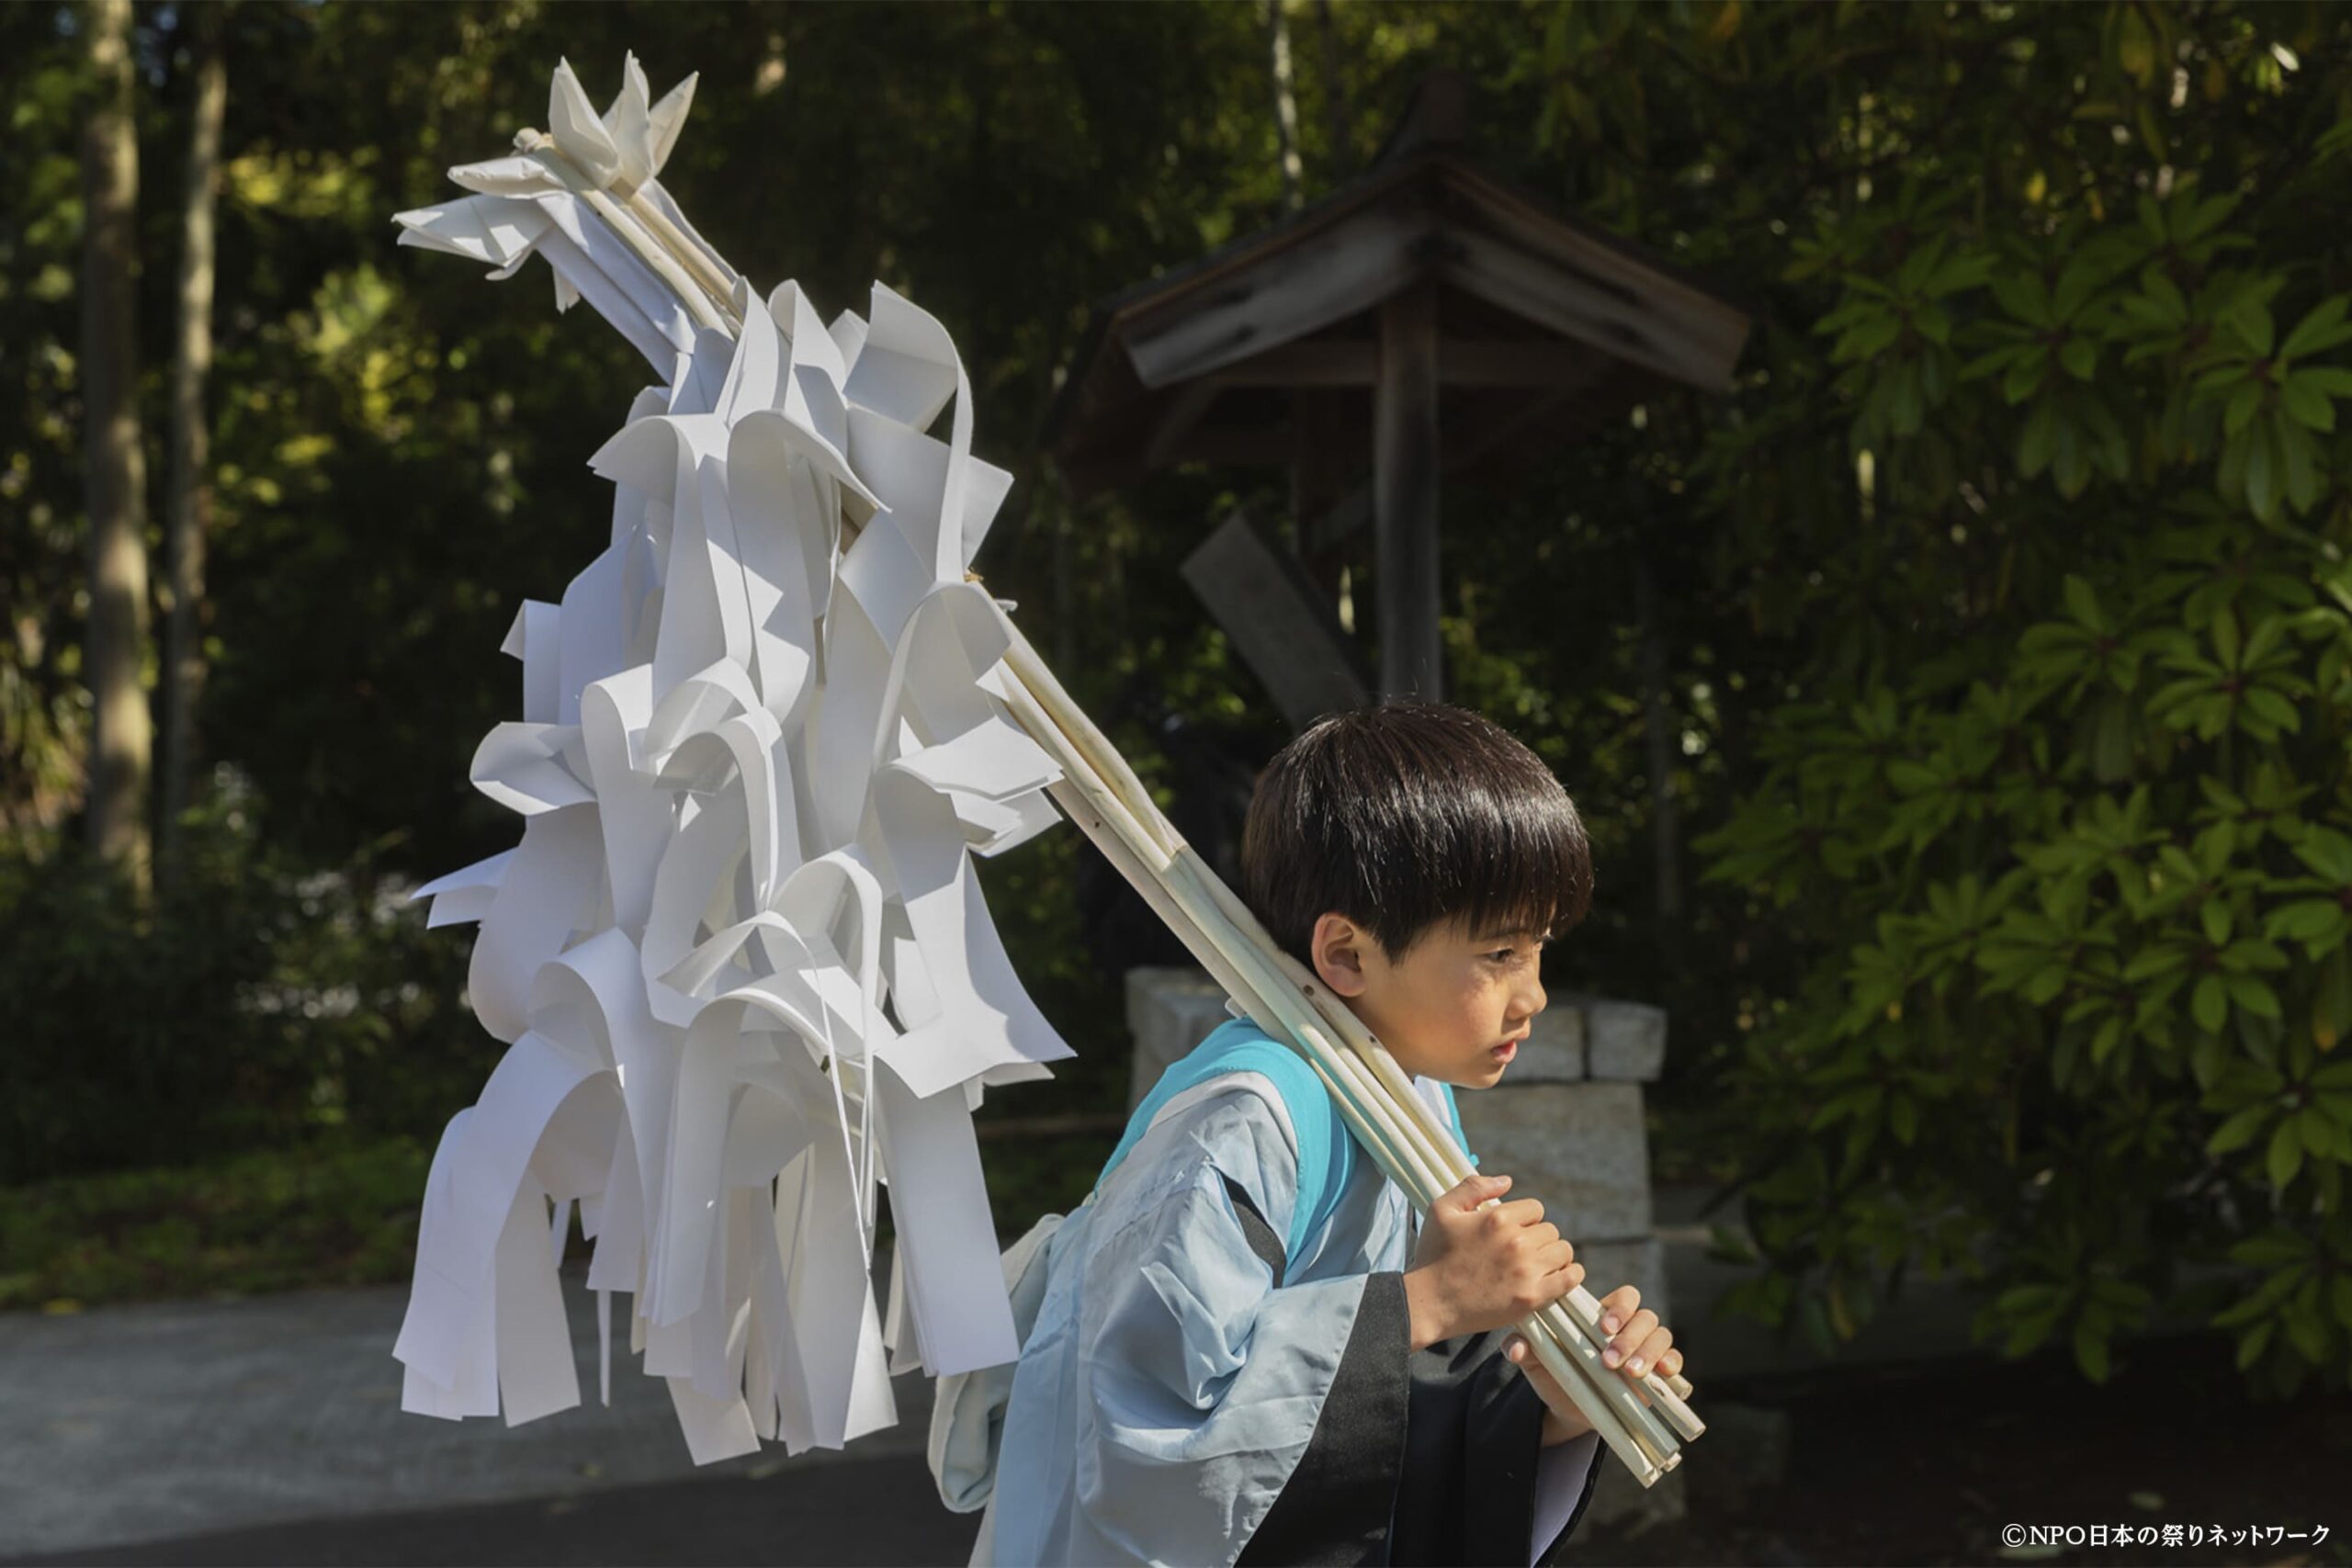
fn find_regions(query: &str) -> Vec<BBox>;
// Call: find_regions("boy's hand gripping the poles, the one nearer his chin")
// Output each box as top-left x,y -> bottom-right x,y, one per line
1404,1173 -> 1585,1349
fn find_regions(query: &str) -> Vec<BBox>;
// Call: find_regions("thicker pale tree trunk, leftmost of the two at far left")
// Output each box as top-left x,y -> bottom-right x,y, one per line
80,0 -> 151,886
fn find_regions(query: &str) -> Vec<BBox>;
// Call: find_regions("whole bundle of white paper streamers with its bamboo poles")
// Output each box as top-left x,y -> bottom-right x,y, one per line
393,59 -> 1701,1483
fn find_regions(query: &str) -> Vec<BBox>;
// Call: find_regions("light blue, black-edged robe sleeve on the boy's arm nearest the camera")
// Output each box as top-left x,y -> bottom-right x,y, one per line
1070,1093 -> 1408,1565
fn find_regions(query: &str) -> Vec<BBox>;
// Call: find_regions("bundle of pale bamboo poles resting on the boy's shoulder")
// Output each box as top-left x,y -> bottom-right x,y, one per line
515,130 -> 1705,1485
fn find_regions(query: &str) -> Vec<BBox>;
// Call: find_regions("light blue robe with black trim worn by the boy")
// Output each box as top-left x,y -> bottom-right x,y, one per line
955,1021 -> 1600,1568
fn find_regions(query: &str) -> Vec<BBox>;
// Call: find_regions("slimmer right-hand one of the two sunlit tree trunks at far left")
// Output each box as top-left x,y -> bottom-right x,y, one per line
155,5 -> 228,874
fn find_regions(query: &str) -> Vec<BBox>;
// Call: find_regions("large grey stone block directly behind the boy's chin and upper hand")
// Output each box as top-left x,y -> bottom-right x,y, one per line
1456,1079 -> 1651,1246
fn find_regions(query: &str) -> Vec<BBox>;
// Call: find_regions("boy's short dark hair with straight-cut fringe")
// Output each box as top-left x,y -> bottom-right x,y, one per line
1242,703 -> 1592,962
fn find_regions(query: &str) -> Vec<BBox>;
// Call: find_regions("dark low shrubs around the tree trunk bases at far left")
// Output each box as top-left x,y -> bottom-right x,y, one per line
0,766 -> 496,1182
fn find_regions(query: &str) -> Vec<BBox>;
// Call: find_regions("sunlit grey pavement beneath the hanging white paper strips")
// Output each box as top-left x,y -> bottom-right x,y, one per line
0,1279 -> 965,1561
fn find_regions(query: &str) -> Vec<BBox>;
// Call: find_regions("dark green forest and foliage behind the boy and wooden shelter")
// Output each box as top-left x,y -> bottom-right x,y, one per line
0,0 -> 2352,1389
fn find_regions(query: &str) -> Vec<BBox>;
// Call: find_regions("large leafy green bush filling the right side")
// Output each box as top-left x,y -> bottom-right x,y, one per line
1609,5 -> 2352,1387
